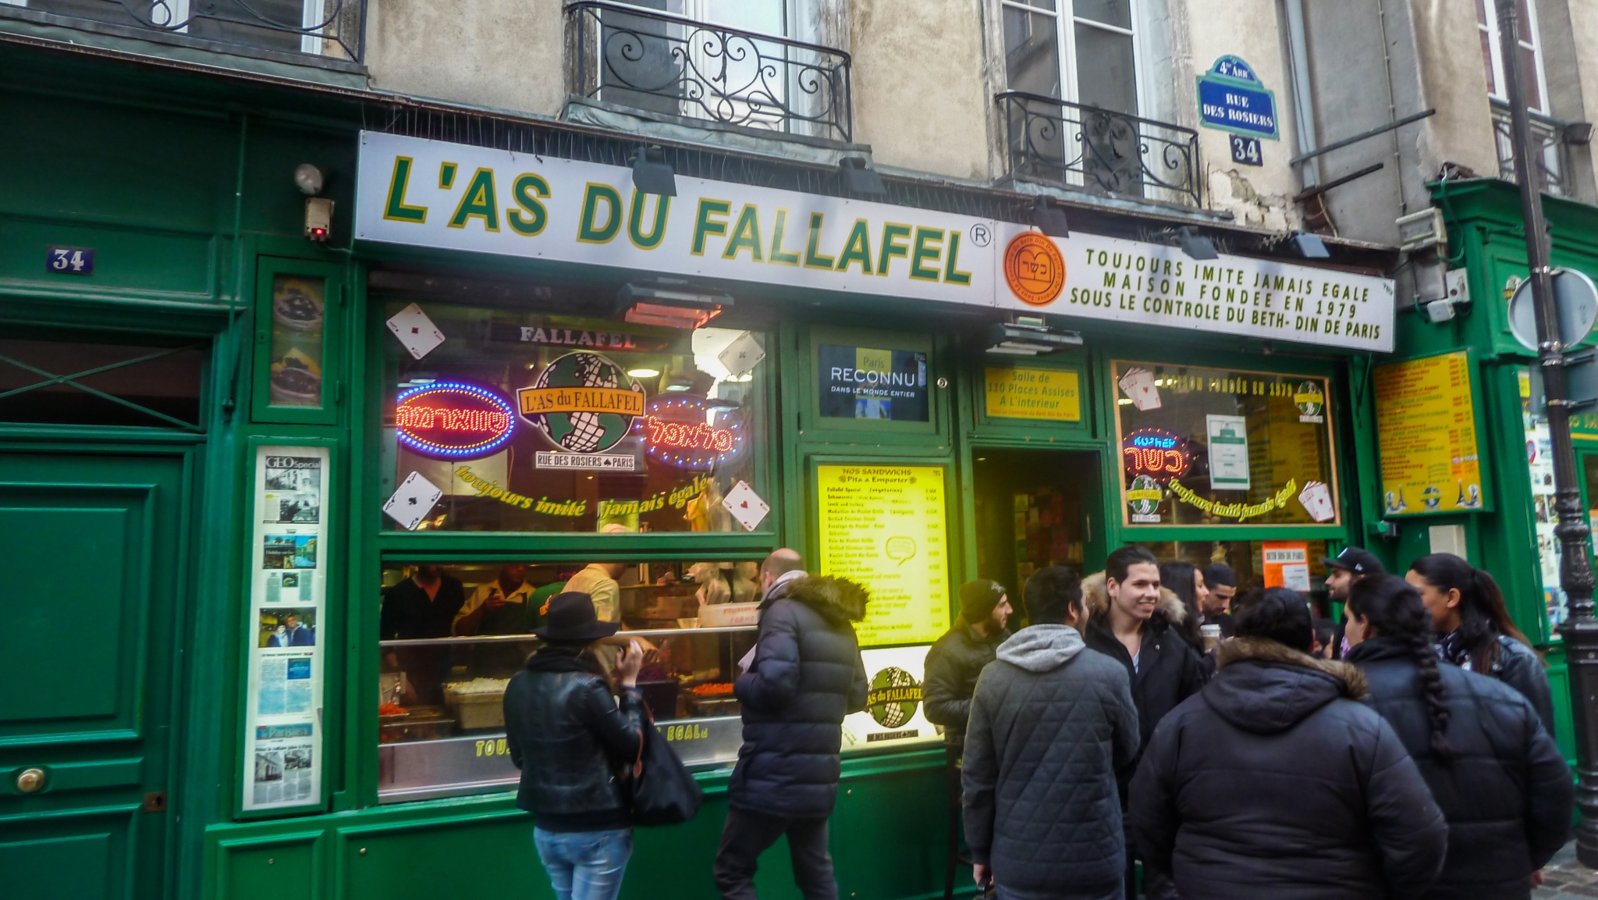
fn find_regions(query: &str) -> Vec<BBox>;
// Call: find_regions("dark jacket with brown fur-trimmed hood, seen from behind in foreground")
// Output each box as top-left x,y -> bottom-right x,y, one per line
1130,638 -> 1448,900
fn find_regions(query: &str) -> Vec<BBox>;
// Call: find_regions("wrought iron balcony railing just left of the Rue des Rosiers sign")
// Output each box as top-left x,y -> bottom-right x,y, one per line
997,91 -> 1203,206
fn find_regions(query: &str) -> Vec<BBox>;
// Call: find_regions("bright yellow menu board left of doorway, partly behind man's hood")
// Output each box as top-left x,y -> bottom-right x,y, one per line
815,464 -> 949,647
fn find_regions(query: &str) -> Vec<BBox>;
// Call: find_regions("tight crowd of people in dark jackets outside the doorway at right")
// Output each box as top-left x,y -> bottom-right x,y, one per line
927,547 -> 1574,900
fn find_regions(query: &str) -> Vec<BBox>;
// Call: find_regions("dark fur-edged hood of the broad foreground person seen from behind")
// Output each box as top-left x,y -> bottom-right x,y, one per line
1202,638 -> 1368,734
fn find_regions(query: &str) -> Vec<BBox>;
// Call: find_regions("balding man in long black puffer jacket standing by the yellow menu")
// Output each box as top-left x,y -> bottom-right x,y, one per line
716,550 -> 868,900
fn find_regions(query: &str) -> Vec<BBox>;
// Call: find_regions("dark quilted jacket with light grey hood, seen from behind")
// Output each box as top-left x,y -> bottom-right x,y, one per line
962,625 -> 1138,900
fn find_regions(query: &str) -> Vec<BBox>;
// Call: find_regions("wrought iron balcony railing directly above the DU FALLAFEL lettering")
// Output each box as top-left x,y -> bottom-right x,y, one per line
566,0 -> 853,142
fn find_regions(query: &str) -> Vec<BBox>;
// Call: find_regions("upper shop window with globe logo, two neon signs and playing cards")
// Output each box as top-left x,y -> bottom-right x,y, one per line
380,301 -> 770,534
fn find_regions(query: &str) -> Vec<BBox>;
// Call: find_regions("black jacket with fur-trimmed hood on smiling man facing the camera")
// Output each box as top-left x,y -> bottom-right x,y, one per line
1082,572 -> 1205,751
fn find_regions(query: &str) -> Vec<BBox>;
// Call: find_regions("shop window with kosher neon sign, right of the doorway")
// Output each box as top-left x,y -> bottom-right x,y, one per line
1114,361 -> 1339,526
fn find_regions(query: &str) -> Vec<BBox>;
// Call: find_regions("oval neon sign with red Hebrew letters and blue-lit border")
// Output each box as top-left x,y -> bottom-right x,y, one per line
395,382 -> 516,459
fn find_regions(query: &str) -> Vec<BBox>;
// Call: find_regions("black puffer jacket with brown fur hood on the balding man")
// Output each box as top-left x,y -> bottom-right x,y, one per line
727,577 -> 866,818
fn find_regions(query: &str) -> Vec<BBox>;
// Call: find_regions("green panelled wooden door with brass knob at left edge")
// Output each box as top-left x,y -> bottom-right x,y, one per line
0,449 -> 189,900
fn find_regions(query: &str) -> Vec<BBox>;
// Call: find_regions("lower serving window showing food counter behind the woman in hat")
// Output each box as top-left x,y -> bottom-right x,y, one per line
377,560 -> 759,802
